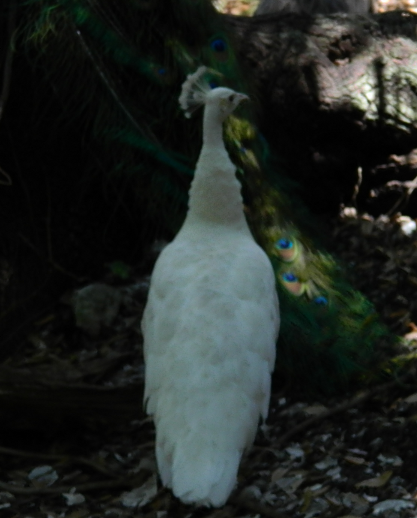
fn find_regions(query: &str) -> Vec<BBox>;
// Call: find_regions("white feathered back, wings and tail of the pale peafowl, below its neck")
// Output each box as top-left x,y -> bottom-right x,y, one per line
142,236 -> 279,505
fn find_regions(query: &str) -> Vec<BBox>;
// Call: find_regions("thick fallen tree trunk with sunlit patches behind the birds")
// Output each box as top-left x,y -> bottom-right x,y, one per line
226,11 -> 417,212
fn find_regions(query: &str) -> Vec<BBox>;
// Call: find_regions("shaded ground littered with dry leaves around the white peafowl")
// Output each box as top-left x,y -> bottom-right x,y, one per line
0,214 -> 417,518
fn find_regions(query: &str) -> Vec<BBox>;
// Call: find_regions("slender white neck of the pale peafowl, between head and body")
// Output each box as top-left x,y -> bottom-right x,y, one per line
185,106 -> 249,232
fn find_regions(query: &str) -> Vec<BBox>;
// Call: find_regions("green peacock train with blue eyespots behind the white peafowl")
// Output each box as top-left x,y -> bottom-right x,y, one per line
12,0 -> 394,392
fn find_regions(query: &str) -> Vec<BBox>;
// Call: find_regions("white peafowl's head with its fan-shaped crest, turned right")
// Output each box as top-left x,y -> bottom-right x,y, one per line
179,67 -> 249,122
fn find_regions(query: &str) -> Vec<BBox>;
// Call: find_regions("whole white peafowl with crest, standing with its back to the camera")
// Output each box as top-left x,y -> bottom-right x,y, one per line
142,67 -> 280,506
